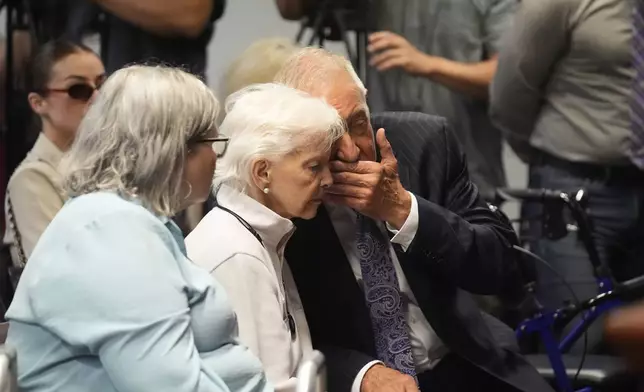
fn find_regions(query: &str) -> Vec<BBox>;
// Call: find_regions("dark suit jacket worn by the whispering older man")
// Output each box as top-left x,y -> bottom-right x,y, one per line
286,113 -> 551,392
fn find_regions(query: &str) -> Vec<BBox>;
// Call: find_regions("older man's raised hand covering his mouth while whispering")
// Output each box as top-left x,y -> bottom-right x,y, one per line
325,128 -> 411,229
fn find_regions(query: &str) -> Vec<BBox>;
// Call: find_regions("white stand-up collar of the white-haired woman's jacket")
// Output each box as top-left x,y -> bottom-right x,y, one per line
215,184 -> 295,253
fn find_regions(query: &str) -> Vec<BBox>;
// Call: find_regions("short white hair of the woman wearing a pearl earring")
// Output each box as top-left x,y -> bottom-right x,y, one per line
214,83 -> 345,193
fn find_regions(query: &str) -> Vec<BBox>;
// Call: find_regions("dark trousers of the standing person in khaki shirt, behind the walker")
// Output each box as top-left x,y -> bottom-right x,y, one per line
522,154 -> 644,352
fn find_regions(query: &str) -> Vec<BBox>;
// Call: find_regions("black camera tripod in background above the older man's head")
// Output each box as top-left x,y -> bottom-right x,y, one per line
295,0 -> 371,86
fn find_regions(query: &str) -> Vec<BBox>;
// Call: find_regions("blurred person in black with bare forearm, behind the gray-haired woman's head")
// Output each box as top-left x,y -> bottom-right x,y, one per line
65,0 -> 226,77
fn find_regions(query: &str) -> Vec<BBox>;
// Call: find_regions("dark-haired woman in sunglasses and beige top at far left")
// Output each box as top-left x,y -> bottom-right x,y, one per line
4,40 -> 105,266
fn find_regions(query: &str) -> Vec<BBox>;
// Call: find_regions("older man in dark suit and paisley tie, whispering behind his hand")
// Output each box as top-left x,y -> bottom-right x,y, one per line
276,48 -> 551,392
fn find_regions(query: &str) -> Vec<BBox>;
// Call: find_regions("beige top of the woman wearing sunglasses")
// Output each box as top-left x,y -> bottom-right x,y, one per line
4,133 -> 66,263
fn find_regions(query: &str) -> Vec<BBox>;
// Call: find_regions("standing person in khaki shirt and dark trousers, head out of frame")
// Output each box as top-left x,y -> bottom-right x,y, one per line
491,0 -> 644,351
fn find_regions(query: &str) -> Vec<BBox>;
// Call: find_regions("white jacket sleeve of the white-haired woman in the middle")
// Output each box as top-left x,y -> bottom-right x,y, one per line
211,253 -> 296,391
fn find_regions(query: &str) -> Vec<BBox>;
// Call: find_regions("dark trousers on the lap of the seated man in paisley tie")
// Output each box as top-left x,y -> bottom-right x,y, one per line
418,353 -> 517,392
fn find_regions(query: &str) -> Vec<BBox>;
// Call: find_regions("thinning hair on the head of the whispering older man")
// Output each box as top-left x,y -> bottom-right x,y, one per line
274,46 -> 369,115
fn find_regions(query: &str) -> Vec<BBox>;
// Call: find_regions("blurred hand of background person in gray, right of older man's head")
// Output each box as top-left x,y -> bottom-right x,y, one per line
367,31 -> 436,75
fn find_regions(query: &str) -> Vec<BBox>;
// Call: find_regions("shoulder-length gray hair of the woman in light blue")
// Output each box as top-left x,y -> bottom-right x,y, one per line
61,66 -> 219,216
